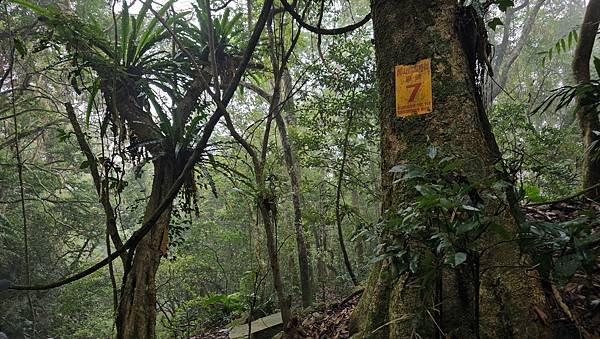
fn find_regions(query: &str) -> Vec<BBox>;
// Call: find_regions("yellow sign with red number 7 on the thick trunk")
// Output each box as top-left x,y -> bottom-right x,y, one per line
395,59 -> 433,117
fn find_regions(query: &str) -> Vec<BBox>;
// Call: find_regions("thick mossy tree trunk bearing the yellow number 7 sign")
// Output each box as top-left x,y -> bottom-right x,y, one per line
351,0 -> 548,338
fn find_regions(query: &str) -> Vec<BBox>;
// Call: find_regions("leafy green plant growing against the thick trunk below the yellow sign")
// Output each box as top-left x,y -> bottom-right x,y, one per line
371,147 -> 516,325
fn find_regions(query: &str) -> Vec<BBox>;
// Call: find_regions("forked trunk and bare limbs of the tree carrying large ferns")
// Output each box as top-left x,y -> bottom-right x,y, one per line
98,75 -> 205,338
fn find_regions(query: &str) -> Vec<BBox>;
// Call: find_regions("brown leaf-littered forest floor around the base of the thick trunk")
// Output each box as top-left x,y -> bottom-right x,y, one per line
194,198 -> 600,339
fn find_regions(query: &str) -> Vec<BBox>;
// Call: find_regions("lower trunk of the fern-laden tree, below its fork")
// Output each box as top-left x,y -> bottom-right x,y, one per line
116,155 -> 187,339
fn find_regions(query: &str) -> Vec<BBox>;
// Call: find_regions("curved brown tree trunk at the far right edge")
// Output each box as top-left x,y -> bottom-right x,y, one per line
573,0 -> 600,199
